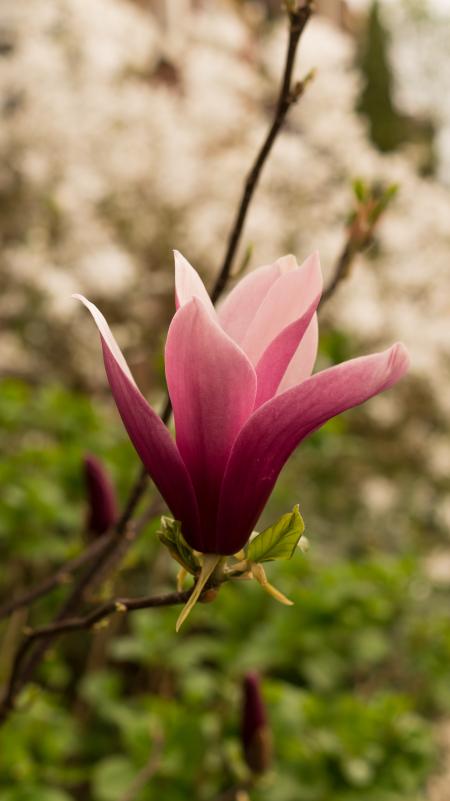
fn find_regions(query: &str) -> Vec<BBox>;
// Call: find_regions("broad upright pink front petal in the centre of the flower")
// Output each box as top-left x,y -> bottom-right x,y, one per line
166,298 -> 256,552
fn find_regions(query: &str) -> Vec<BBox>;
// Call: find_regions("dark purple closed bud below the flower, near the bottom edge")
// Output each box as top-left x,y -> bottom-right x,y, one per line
241,673 -> 272,773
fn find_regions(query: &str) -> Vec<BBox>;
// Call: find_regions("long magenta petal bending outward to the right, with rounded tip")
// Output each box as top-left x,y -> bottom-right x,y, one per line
217,344 -> 409,554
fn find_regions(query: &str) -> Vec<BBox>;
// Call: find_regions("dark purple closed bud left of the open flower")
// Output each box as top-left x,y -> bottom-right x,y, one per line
84,454 -> 118,537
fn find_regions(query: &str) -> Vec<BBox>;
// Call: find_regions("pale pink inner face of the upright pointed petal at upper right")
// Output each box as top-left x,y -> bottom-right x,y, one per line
241,253 -> 322,364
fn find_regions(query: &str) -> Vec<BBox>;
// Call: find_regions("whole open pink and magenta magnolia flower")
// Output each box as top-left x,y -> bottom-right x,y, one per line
75,253 -> 408,556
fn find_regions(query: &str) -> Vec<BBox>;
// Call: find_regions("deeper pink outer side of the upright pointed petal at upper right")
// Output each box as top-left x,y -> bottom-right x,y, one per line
255,295 -> 320,409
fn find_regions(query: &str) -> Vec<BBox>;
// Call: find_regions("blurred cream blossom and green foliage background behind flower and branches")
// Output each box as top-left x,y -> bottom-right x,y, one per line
0,0 -> 450,801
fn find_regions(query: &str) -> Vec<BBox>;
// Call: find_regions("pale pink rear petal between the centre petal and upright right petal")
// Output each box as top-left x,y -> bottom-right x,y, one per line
217,257 -> 288,344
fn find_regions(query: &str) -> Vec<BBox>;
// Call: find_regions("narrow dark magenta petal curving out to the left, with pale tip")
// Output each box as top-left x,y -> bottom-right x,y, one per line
74,295 -> 199,548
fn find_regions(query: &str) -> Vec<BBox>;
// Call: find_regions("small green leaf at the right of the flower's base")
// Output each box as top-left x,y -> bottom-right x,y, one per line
246,505 -> 305,562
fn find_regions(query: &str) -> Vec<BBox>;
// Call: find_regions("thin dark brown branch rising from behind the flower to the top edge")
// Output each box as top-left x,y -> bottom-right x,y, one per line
211,0 -> 312,303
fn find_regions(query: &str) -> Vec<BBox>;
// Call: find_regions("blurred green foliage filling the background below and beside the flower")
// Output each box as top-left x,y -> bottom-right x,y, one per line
0,376 -> 450,801
